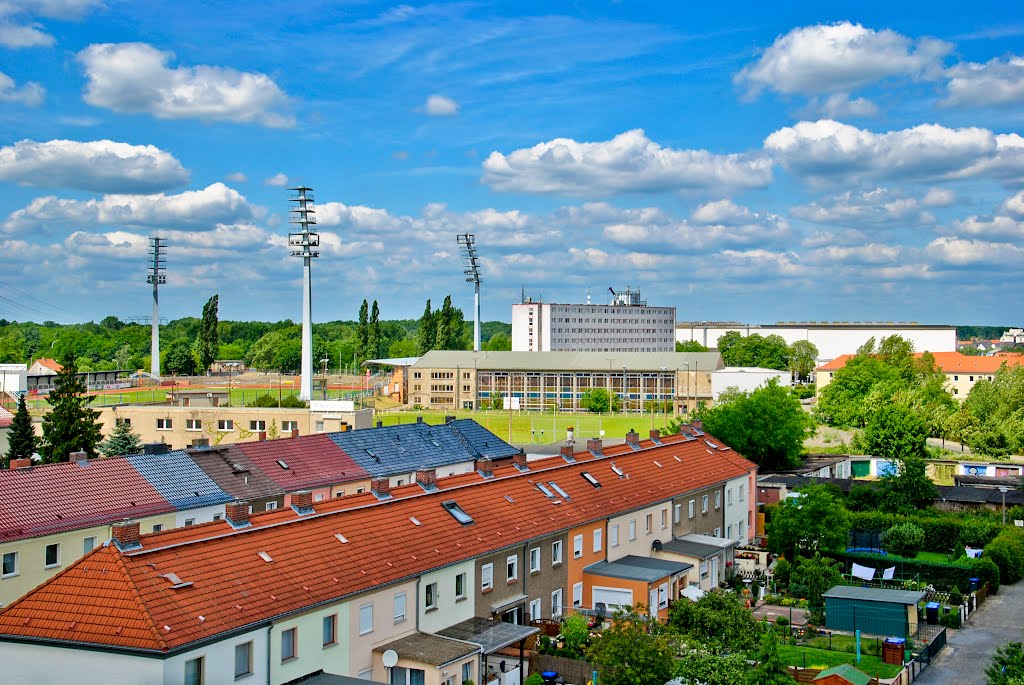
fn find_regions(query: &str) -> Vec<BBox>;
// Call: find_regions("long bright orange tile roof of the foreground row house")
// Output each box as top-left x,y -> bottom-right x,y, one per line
0,436 -> 756,652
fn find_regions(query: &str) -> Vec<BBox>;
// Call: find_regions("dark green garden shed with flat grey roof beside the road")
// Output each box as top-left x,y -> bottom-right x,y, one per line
822,585 -> 925,638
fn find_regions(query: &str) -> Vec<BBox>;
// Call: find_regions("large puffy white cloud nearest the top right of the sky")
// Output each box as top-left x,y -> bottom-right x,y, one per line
734,22 -> 952,96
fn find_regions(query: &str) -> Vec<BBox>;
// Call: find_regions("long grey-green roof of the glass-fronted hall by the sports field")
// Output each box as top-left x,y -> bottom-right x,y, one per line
413,350 -> 725,373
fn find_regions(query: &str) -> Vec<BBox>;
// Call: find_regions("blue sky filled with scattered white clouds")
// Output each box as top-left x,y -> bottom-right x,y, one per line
0,0 -> 1024,326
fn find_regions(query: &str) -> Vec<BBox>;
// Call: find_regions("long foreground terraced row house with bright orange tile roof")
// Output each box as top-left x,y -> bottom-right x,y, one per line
0,426 -> 757,685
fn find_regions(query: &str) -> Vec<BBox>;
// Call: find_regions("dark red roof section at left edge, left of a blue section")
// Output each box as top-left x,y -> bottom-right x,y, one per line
0,457 -> 175,542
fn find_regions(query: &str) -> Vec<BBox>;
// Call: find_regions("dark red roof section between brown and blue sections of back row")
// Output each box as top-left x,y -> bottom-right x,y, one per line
236,433 -> 370,493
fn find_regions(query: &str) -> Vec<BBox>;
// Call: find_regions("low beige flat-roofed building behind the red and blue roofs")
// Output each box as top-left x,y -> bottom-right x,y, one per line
91,404 -> 373,449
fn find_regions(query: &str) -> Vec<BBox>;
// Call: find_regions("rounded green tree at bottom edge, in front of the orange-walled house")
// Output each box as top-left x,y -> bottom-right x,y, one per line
587,605 -> 675,685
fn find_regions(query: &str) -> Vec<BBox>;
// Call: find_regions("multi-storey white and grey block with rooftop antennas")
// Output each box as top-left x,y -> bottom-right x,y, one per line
512,288 -> 676,352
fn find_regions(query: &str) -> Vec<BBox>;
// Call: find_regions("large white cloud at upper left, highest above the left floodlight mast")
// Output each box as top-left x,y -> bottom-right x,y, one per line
78,43 -> 295,127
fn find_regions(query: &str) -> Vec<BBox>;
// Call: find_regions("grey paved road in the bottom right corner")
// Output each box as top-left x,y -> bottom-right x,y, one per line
914,582 -> 1024,685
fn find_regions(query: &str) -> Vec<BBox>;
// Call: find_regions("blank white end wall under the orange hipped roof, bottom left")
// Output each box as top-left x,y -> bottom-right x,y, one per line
0,642 -> 160,685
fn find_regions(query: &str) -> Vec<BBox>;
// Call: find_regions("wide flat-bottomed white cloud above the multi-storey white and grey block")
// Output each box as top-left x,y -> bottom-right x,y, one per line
483,129 -> 772,196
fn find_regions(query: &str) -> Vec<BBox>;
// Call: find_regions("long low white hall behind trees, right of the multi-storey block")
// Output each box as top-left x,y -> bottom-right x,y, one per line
675,322 -> 956,361
